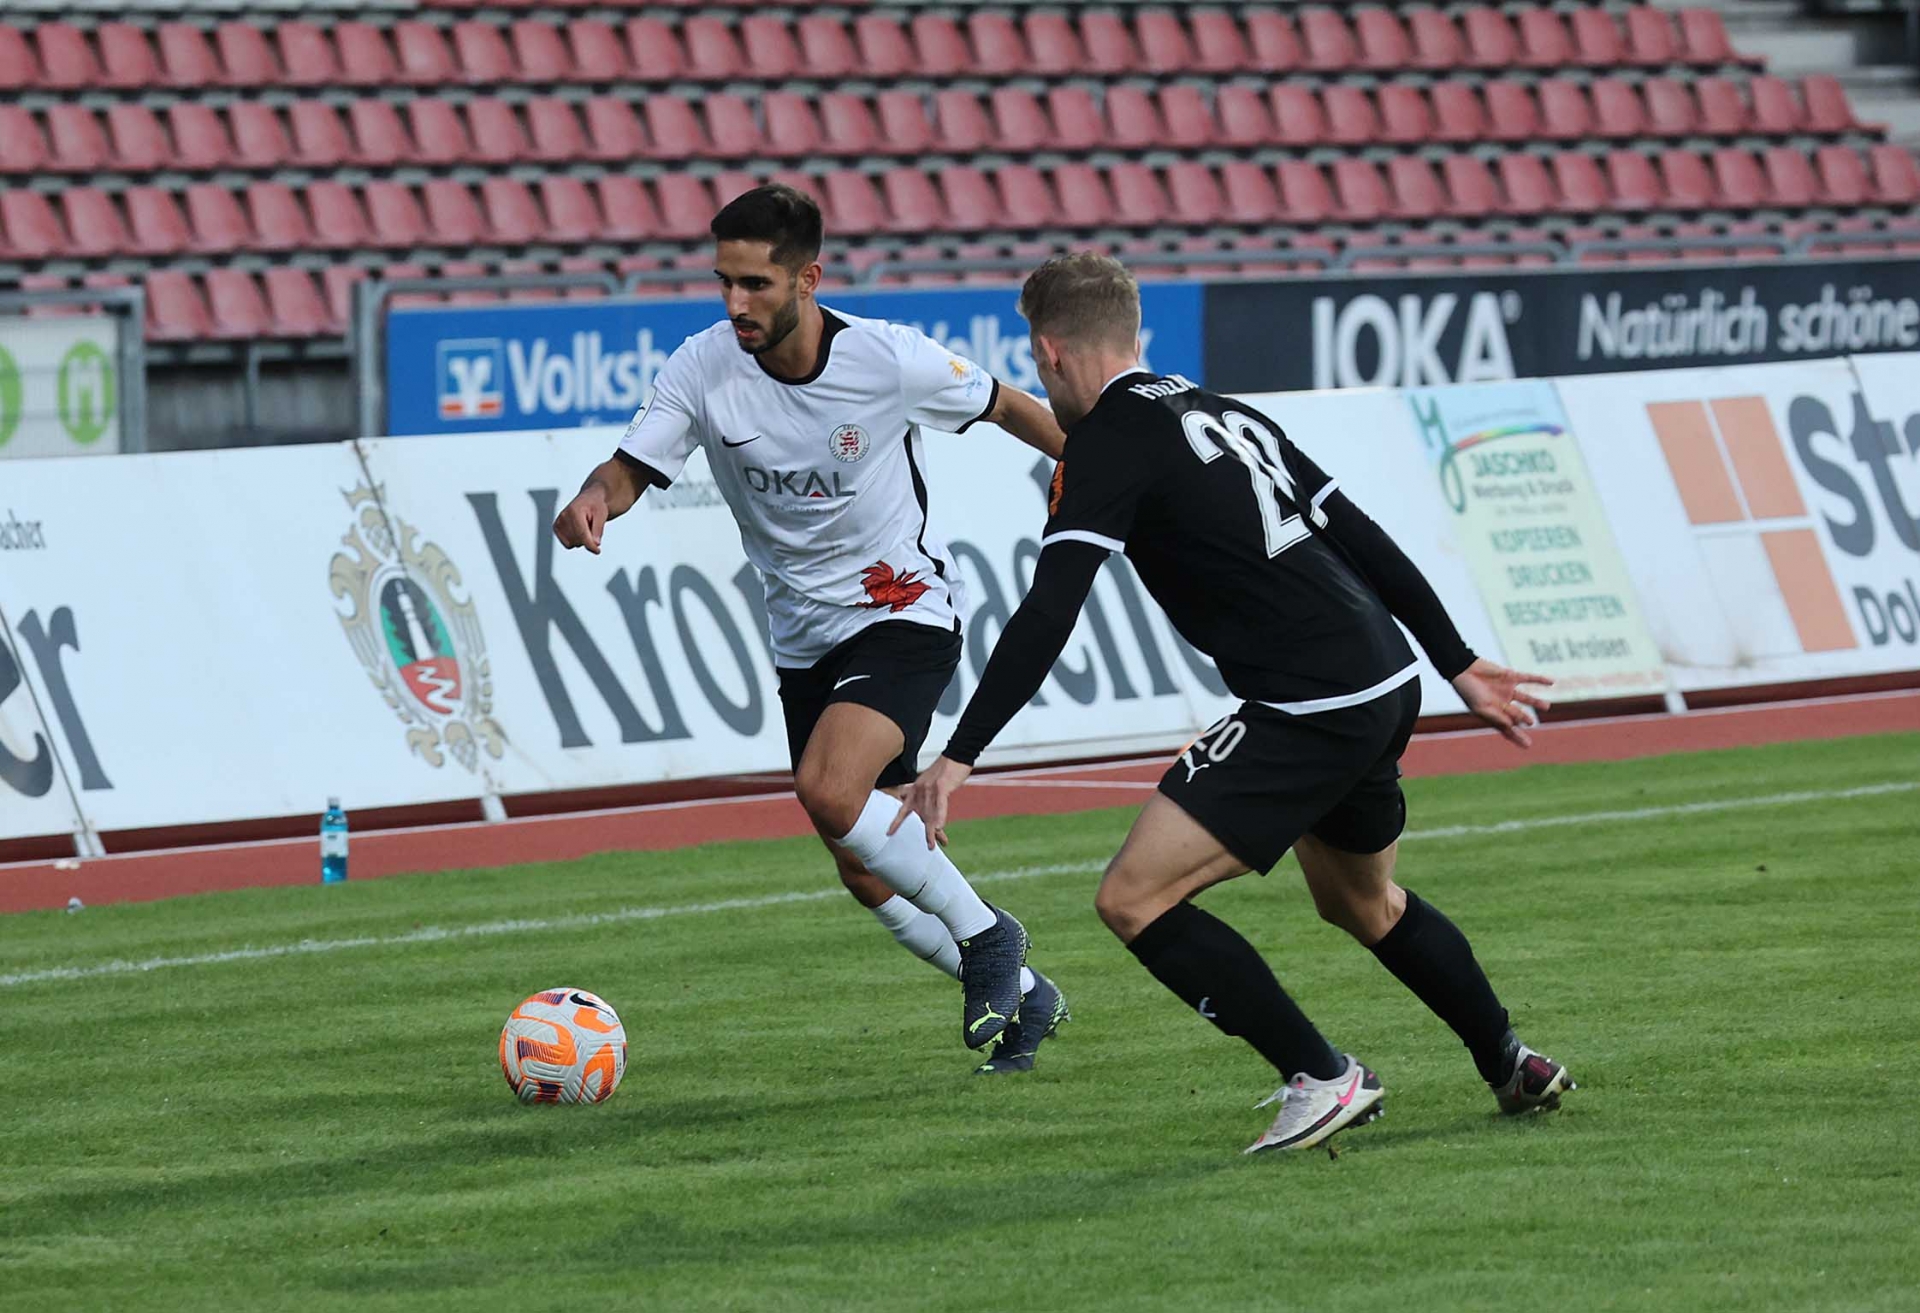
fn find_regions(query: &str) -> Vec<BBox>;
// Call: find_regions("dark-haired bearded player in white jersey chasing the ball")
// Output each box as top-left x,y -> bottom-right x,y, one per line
553,184 -> 1068,1073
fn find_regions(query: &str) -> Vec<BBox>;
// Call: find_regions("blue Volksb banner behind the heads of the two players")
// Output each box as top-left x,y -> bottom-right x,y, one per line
386,282 -> 1206,434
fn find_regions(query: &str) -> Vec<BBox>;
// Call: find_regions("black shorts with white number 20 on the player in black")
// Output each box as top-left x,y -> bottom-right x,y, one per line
1160,680 -> 1421,873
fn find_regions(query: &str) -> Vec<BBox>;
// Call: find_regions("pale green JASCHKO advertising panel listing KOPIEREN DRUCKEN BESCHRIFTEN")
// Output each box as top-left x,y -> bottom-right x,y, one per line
1404,380 -> 1667,703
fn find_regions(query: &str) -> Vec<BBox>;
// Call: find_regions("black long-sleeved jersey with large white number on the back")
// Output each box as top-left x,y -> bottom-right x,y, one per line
947,370 -> 1473,764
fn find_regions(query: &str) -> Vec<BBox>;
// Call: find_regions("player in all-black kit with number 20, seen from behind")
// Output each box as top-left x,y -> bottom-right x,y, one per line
900,253 -> 1574,1154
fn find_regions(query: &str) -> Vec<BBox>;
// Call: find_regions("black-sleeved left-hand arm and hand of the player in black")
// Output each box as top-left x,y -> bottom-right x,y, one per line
887,541 -> 1106,848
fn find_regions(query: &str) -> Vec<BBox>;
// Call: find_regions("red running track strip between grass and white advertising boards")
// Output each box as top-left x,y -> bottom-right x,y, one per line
0,689 -> 1920,912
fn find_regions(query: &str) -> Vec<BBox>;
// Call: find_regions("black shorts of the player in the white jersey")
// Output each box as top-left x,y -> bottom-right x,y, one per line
776,620 -> 960,789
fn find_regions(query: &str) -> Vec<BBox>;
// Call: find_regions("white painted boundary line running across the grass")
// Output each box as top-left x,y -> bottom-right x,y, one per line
0,779 -> 1920,989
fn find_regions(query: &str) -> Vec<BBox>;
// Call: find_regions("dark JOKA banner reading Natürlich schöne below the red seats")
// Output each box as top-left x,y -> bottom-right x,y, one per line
1206,259 -> 1920,392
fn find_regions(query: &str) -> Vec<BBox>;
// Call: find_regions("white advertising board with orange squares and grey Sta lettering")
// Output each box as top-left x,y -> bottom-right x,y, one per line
1557,359 -> 1920,691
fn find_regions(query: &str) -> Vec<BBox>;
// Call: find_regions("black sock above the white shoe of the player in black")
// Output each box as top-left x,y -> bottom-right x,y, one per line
1127,902 -> 1346,1081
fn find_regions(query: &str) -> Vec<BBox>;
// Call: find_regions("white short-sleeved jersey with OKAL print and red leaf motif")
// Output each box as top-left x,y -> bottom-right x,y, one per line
620,307 -> 998,666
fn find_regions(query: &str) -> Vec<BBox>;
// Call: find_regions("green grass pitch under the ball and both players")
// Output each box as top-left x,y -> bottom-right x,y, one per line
0,735 -> 1920,1313
